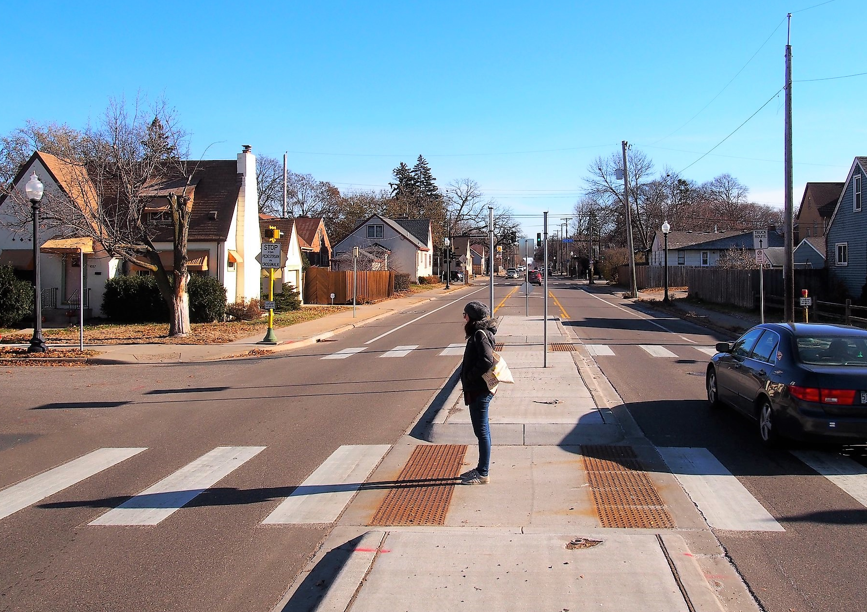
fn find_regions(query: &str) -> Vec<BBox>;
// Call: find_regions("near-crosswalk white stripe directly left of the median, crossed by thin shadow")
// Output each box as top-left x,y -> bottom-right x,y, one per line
262,444 -> 391,525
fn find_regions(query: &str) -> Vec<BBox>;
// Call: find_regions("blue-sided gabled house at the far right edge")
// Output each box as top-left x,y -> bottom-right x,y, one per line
825,157 -> 867,298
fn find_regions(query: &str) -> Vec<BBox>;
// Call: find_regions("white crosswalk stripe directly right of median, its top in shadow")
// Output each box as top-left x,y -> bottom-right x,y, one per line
657,447 -> 785,531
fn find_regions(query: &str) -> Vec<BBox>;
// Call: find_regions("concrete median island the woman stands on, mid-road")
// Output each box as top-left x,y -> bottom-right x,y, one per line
274,317 -> 758,612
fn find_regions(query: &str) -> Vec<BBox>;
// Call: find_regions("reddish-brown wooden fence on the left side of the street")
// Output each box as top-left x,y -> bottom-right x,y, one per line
304,267 -> 394,304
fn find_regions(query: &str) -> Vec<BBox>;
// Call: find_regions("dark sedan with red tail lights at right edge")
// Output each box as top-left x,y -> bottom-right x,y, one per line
705,323 -> 867,446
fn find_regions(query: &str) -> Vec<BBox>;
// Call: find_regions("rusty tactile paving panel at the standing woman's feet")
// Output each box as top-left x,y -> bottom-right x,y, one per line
369,444 -> 467,525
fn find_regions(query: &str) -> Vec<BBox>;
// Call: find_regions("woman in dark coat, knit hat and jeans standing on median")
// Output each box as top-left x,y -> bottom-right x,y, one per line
461,302 -> 497,485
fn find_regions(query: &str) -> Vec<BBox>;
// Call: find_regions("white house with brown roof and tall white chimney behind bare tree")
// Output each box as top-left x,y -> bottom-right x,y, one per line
0,145 -> 261,318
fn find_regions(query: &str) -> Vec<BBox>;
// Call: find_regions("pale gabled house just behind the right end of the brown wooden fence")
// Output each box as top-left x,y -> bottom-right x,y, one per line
332,215 -> 433,280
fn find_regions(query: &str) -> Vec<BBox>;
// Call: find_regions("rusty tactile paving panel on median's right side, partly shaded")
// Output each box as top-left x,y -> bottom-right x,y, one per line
581,446 -> 674,529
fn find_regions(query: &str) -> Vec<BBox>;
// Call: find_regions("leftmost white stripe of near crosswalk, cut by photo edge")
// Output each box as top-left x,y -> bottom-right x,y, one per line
0,448 -> 147,519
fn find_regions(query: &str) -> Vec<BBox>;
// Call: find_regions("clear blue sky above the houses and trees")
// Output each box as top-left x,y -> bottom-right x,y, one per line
0,0 -> 867,234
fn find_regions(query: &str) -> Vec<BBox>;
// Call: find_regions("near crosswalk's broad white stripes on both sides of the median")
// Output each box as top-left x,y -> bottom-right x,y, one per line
0,444 -> 867,532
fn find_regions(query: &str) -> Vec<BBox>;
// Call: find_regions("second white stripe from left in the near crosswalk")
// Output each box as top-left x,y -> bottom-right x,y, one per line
90,446 -> 265,525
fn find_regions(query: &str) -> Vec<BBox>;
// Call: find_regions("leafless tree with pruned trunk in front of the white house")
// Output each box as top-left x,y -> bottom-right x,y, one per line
4,100 -> 196,336
